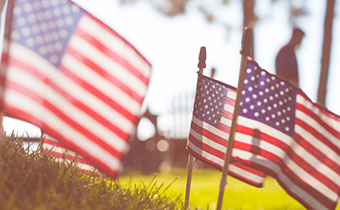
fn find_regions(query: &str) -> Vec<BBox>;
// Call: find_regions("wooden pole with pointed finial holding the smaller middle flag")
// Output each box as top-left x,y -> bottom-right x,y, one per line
184,47 -> 207,209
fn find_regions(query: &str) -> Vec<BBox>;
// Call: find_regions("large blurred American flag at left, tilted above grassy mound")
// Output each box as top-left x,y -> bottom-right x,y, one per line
3,0 -> 151,177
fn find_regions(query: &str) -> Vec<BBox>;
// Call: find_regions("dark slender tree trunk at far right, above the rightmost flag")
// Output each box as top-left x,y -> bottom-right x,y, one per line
318,0 -> 335,106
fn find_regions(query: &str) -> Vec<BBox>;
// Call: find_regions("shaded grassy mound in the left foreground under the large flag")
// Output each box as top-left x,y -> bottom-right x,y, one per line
0,136 -> 183,210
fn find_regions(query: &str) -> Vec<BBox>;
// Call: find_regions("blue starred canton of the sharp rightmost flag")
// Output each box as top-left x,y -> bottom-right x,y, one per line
240,63 -> 296,136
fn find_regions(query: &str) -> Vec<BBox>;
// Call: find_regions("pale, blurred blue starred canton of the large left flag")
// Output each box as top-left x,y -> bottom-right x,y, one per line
11,0 -> 83,68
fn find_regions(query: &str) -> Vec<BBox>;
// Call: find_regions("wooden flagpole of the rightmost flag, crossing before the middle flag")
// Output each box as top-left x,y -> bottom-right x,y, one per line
216,27 -> 253,210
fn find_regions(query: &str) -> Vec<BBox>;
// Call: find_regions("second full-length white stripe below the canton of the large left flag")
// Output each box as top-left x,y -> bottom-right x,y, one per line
7,67 -> 128,152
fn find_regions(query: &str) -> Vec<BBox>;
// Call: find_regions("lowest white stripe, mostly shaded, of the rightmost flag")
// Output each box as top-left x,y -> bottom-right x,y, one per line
234,149 -> 327,210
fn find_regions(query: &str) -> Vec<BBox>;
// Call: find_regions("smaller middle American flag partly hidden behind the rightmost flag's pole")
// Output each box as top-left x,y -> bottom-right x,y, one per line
187,74 -> 265,187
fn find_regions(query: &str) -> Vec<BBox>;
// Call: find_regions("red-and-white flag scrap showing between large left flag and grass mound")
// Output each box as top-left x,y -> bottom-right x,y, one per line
42,135 -> 98,174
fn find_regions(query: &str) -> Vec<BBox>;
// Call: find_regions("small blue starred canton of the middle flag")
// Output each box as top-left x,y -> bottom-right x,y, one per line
193,75 -> 228,128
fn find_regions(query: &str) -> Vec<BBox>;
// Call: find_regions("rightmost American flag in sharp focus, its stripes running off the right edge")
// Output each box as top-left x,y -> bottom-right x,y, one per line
233,61 -> 340,210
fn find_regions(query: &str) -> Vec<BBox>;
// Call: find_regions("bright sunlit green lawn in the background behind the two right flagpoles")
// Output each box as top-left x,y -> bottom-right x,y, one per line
119,169 -> 340,210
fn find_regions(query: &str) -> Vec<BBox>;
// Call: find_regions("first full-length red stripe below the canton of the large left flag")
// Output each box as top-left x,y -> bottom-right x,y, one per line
8,58 -> 129,143
